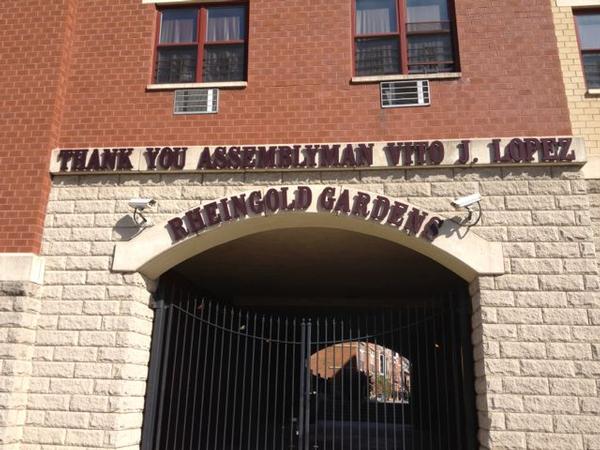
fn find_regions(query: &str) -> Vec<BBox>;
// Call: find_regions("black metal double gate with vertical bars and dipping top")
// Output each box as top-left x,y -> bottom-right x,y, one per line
142,282 -> 476,450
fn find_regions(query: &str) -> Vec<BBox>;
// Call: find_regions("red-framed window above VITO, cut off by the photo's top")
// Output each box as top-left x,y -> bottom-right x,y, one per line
353,0 -> 457,76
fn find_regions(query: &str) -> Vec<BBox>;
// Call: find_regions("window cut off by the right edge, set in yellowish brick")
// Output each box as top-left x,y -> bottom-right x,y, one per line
575,11 -> 600,89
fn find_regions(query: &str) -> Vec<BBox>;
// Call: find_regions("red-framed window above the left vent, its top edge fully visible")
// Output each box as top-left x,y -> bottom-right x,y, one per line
154,5 -> 247,83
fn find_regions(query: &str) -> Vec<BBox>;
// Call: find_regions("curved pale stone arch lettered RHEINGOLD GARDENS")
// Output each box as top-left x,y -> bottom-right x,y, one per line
112,186 -> 504,282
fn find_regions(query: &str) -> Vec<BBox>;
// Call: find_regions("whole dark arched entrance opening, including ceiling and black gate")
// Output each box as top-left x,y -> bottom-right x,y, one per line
143,227 -> 476,450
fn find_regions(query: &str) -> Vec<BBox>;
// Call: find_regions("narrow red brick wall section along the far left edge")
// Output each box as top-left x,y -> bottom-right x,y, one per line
0,0 -> 74,252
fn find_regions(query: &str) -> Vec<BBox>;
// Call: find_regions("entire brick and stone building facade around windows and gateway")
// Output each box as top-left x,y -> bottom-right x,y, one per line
0,0 -> 600,450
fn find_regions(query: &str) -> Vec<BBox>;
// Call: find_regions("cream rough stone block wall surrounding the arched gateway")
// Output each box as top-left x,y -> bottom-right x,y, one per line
21,167 -> 600,450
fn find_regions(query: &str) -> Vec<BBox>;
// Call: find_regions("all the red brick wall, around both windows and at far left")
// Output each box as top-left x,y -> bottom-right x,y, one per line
0,0 -> 570,251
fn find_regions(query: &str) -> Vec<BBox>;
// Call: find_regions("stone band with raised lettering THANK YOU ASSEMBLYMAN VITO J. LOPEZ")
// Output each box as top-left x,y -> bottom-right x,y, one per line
51,137 -> 585,174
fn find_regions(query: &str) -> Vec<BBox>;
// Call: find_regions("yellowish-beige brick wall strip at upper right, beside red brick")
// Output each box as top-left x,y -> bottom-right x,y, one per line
548,0 -> 600,155
